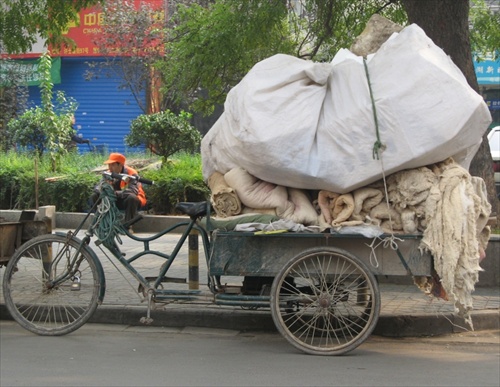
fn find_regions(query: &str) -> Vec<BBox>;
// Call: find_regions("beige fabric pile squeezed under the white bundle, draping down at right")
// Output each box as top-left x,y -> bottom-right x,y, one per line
208,159 -> 491,323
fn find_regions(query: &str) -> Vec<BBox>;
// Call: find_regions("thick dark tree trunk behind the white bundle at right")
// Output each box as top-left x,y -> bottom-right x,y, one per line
402,0 -> 500,220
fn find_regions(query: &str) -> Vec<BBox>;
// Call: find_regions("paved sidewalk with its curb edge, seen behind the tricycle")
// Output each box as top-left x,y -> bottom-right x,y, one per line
0,229 -> 500,336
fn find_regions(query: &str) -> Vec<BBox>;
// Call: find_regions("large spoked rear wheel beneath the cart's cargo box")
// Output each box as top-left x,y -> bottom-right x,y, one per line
271,247 -> 380,355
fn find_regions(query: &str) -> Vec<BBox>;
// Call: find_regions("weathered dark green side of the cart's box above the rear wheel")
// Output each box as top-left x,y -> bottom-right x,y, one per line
209,230 -> 432,276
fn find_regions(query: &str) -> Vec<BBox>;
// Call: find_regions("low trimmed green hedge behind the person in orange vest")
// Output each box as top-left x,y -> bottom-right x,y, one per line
0,152 -> 210,215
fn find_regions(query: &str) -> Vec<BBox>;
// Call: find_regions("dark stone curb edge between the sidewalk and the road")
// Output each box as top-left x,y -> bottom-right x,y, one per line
0,304 -> 500,337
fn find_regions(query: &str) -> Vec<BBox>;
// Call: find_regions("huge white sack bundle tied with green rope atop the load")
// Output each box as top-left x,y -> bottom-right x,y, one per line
202,25 -> 491,193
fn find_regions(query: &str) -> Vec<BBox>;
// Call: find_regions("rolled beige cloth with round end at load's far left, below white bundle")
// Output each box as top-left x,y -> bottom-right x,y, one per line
208,172 -> 241,218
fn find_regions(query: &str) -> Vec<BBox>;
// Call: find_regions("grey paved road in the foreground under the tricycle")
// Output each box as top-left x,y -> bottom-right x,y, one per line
0,321 -> 500,387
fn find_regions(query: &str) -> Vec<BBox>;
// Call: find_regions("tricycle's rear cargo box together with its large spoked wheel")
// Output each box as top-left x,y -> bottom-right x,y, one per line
208,231 -> 431,355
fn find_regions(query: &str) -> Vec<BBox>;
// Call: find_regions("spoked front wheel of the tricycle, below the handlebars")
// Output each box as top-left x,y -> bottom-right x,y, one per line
3,234 -> 103,336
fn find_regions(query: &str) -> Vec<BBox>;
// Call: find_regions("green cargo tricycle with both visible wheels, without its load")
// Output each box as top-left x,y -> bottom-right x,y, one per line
3,174 -> 431,355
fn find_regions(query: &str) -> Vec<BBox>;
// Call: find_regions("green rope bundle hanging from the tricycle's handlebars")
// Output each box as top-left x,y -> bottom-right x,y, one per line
94,182 -> 125,249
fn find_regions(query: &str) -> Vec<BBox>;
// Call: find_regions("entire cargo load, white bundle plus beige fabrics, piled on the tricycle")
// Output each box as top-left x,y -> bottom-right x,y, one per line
201,21 -> 491,326
